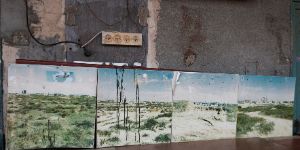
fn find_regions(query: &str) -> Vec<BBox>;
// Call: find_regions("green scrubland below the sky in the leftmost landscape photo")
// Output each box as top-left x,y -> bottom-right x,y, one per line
7,94 -> 96,150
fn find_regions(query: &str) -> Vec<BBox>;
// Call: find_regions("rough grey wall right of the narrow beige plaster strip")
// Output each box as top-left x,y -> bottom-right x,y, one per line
156,0 -> 291,76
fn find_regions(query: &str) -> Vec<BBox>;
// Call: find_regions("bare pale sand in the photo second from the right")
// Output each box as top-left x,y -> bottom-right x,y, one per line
172,110 -> 236,142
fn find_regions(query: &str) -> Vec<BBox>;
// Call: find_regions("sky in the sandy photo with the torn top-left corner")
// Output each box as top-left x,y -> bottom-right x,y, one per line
174,72 -> 239,104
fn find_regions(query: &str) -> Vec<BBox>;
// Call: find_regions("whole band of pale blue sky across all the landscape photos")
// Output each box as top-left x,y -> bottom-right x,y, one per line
8,64 -> 296,103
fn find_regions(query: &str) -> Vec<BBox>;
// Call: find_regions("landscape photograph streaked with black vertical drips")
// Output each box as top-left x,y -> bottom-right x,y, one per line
97,69 -> 173,148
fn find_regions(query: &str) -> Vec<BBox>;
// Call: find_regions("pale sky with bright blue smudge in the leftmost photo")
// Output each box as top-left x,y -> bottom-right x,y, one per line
8,64 -> 97,96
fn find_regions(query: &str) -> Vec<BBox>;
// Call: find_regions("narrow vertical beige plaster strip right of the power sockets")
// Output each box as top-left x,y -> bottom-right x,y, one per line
147,0 -> 161,68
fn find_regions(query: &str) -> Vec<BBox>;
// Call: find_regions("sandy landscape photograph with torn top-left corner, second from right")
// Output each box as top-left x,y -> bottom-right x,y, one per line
172,72 -> 239,142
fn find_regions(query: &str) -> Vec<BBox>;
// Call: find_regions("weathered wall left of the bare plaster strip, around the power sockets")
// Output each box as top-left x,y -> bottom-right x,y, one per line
1,0 -> 148,65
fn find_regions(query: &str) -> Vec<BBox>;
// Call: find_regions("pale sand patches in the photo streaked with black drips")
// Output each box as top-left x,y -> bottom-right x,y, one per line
97,109 -> 171,147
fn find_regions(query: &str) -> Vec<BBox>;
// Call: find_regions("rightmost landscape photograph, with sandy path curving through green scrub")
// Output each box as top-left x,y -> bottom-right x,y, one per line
237,75 -> 296,138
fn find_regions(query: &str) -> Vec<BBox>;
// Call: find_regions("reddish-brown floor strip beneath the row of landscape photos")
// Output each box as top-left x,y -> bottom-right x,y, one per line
102,137 -> 300,150
